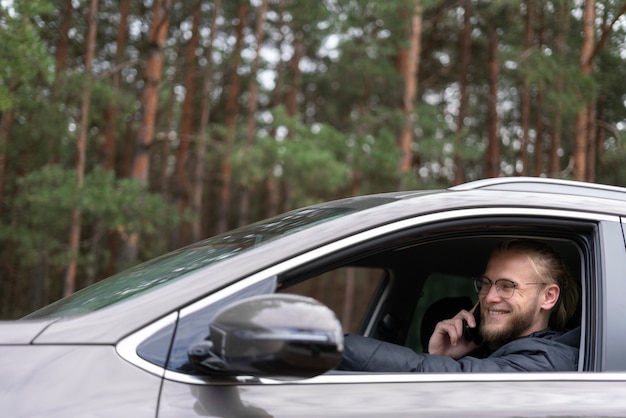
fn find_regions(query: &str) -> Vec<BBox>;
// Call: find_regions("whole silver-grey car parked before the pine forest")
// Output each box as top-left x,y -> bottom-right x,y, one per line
0,177 -> 626,418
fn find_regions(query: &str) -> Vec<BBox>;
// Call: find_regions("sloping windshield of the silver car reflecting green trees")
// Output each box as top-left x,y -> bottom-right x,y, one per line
24,197 -> 394,319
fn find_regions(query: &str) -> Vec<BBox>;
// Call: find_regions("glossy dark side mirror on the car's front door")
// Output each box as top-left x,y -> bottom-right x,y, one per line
189,294 -> 343,378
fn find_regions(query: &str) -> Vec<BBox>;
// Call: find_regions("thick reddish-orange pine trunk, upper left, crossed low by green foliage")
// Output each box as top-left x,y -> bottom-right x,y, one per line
120,0 -> 171,268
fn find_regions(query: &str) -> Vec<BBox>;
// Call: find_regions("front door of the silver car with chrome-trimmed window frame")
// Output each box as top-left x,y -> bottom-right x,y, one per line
135,207 -> 626,417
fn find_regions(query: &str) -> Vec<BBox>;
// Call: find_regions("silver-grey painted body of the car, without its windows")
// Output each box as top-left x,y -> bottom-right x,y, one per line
0,178 -> 626,418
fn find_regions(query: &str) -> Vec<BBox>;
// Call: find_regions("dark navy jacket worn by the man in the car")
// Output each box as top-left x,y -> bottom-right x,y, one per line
338,328 -> 580,372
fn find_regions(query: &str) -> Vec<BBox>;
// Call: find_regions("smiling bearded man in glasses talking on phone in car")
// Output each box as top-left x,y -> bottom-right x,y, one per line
339,240 -> 580,372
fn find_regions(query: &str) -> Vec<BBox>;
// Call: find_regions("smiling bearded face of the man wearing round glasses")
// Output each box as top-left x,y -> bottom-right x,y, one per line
479,252 -> 546,344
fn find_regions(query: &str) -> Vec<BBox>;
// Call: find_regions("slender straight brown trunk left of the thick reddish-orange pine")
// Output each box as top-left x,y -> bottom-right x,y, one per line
63,0 -> 98,297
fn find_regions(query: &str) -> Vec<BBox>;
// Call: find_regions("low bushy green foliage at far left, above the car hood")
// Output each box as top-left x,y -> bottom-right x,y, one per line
0,166 -> 180,274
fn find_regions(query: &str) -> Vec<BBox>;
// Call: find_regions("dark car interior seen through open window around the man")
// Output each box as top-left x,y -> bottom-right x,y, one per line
278,219 -> 592,367
